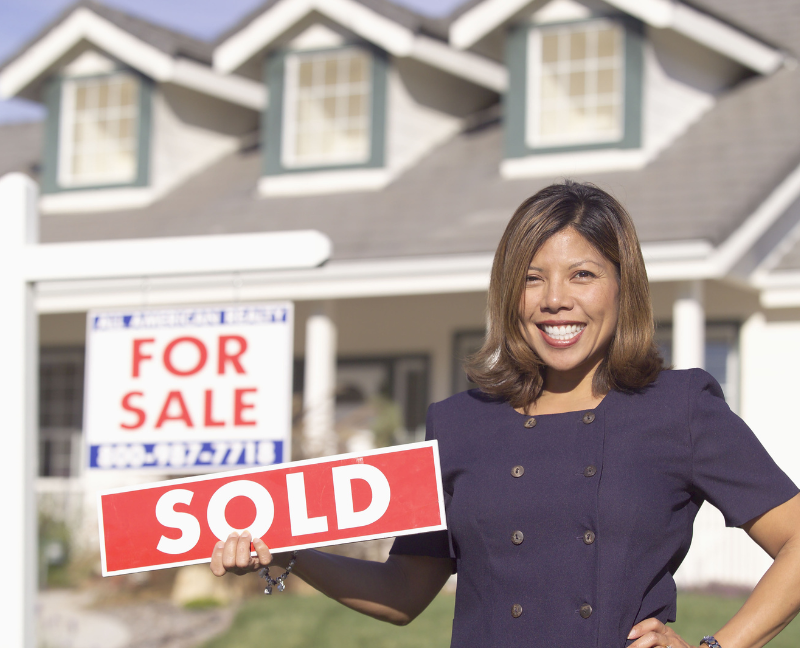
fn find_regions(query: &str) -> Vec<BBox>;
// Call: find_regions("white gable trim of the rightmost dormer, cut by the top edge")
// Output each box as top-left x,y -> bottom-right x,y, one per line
449,0 -> 784,74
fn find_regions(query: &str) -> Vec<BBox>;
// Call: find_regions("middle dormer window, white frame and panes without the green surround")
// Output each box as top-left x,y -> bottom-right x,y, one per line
282,49 -> 372,168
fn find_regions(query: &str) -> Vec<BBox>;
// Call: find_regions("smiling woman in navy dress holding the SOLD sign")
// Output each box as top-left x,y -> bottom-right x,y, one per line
211,182 -> 800,648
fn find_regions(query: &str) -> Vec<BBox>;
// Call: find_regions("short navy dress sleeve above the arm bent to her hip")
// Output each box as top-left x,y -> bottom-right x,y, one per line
689,369 -> 798,527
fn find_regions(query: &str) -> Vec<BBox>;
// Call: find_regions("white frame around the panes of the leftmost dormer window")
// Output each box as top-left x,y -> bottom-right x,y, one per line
57,72 -> 143,188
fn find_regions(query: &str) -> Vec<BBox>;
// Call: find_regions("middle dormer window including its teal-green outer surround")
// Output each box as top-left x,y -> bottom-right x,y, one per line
263,45 -> 386,176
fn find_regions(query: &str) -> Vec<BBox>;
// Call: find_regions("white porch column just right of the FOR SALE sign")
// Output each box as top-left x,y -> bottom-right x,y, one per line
302,301 -> 338,457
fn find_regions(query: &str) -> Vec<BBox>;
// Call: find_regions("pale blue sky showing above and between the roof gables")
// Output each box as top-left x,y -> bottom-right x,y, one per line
0,0 -> 465,123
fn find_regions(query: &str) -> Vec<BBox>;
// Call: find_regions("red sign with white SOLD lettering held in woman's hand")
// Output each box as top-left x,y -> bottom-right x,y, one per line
98,441 -> 446,576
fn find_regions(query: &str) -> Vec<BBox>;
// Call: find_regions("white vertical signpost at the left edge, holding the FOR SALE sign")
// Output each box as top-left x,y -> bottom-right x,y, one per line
0,173 -> 39,648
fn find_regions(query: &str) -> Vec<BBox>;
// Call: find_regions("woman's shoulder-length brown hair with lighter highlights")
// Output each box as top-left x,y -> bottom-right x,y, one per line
464,180 -> 664,407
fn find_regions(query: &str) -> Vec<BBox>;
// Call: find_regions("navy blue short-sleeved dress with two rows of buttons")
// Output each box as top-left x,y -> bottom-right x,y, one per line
392,369 -> 798,648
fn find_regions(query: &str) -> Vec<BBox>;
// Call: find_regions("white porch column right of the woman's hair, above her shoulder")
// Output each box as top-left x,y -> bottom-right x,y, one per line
672,280 -> 706,369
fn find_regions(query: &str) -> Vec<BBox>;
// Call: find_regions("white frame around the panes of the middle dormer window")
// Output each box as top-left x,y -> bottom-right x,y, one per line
281,47 -> 375,169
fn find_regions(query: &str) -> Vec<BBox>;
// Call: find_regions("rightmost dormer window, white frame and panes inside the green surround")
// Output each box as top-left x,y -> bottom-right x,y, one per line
526,21 -> 625,148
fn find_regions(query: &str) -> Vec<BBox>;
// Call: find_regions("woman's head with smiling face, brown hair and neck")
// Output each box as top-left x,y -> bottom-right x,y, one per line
466,182 -> 663,413
